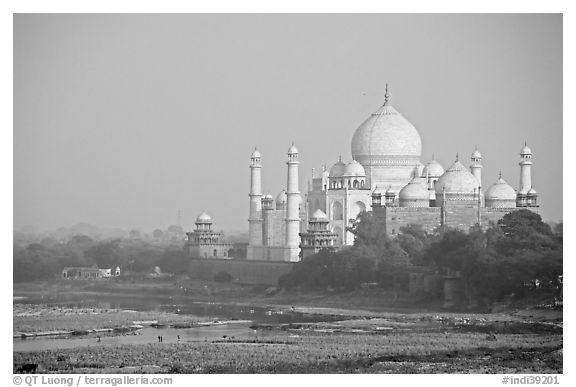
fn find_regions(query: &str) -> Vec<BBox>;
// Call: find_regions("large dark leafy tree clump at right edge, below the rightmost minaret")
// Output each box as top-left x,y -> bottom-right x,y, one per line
423,210 -> 562,308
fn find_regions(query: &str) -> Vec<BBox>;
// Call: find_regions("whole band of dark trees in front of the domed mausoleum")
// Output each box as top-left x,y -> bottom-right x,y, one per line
279,210 -> 563,303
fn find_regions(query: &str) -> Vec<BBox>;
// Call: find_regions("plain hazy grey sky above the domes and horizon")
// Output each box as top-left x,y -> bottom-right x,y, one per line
14,14 -> 562,231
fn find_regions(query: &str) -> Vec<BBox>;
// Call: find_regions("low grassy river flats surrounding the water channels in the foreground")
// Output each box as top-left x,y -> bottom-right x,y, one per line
13,280 -> 563,374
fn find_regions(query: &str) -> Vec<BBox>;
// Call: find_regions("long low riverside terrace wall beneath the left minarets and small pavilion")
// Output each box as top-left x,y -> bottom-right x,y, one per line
190,260 -> 294,286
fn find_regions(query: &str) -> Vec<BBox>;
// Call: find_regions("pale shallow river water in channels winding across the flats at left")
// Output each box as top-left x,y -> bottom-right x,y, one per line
13,294 -> 338,352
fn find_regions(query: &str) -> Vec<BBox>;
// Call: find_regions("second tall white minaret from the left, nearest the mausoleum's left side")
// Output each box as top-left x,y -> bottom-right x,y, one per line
284,144 -> 300,261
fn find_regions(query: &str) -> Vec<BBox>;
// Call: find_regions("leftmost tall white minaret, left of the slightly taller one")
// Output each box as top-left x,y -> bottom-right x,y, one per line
246,148 -> 263,259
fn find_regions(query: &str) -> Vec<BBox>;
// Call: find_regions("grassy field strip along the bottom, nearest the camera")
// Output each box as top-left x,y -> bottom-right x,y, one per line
14,332 -> 562,373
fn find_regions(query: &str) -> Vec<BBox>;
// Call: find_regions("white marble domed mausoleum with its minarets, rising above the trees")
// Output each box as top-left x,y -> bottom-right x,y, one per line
247,87 -> 538,261
